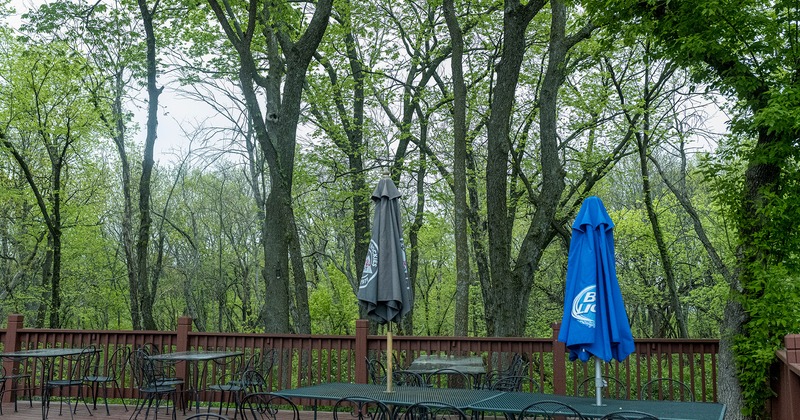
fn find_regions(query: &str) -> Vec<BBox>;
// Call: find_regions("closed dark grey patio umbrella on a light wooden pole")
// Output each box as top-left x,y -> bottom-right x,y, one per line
357,172 -> 414,392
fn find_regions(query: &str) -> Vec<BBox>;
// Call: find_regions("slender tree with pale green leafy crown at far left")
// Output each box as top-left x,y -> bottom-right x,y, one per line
0,43 -> 104,328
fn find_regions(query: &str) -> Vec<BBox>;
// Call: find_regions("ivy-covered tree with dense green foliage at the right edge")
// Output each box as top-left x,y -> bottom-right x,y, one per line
590,0 -> 800,418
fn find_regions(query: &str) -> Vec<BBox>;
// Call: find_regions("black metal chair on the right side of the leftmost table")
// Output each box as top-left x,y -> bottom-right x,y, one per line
42,346 -> 97,418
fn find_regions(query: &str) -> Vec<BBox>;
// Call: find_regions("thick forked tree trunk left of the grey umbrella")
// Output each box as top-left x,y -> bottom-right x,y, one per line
208,0 -> 333,333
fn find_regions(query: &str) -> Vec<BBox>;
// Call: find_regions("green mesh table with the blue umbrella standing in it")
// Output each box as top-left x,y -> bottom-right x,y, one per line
469,392 -> 725,420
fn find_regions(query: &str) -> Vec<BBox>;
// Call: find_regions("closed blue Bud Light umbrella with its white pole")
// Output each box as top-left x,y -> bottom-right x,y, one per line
558,197 -> 634,405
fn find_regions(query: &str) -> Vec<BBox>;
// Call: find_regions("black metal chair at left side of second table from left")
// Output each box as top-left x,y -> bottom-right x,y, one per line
130,348 -> 178,420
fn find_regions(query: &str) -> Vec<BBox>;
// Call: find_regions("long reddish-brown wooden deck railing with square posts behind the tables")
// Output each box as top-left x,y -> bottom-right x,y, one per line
0,315 -> 719,401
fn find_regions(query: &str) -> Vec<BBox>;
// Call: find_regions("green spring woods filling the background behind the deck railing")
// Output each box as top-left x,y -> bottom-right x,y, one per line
0,0 -> 800,418
